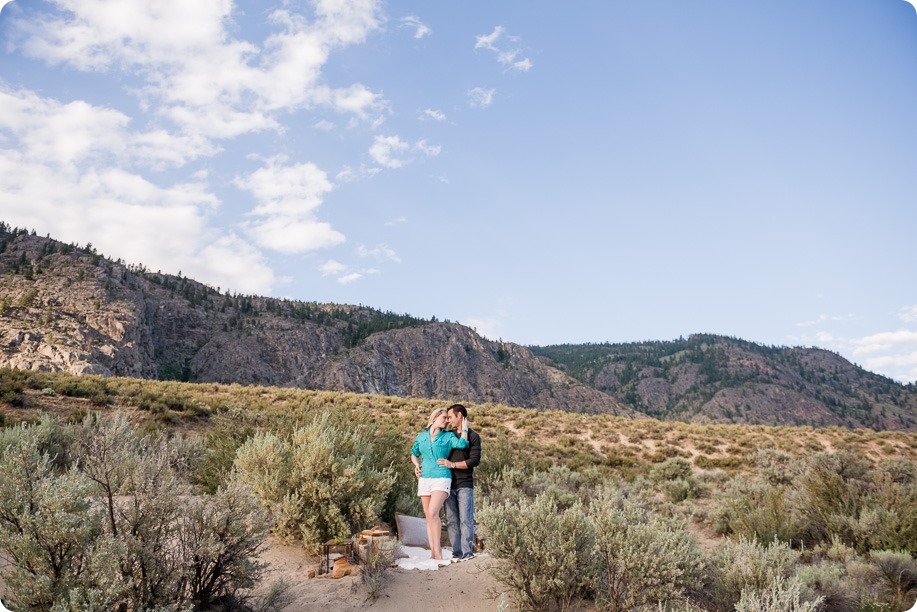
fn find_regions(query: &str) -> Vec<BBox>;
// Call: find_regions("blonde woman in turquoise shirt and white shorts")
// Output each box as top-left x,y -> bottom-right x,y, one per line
411,408 -> 468,559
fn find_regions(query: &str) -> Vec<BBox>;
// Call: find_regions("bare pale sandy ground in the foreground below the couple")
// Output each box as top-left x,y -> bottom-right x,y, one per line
262,543 -> 515,612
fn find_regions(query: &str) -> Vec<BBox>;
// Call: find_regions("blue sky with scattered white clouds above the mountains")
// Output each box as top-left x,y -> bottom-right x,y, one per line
0,0 -> 917,382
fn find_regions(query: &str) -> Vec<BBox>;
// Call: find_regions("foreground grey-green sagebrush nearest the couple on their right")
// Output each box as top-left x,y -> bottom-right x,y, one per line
478,496 -> 593,611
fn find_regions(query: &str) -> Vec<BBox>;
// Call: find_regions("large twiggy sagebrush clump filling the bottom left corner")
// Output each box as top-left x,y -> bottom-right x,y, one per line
0,415 -> 267,610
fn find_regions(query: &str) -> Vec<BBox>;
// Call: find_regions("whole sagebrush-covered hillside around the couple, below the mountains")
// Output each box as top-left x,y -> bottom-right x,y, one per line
0,369 -> 917,611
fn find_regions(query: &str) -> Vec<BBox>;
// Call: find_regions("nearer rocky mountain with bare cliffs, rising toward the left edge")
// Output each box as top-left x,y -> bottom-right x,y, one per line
0,231 -> 637,415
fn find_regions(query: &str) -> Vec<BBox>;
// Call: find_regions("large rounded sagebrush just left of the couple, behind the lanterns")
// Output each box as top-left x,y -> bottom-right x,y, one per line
235,413 -> 395,550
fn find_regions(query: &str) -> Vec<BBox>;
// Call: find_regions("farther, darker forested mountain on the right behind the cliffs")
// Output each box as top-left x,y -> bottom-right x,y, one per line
530,334 -> 917,430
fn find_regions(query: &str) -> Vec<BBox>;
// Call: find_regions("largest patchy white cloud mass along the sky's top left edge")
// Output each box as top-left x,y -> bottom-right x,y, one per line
14,0 -> 385,138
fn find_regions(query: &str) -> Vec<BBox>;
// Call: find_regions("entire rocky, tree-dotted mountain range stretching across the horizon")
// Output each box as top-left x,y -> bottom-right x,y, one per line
0,223 -> 917,430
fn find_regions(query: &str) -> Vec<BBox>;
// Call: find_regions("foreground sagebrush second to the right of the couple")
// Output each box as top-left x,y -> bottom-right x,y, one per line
589,489 -> 704,611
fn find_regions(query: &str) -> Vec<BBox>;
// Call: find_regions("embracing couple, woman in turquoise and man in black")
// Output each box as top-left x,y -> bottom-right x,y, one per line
411,404 -> 481,560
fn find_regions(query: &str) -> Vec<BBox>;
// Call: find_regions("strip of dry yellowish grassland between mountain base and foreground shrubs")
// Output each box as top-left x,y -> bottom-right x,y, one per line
0,371 -> 917,478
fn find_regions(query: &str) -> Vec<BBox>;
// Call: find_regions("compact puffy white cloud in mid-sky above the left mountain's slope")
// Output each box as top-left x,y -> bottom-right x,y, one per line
234,157 -> 345,253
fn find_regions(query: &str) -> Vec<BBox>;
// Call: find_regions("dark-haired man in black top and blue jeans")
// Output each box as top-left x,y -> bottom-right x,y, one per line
437,404 -> 481,560
